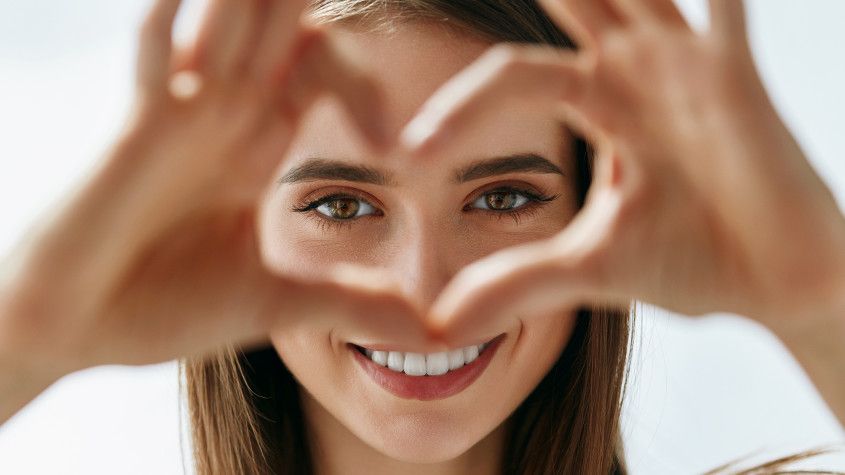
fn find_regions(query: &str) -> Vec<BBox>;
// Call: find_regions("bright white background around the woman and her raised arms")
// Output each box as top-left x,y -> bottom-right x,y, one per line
0,0 -> 845,474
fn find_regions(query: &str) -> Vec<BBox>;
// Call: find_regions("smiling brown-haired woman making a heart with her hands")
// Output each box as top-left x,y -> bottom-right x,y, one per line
0,0 -> 845,473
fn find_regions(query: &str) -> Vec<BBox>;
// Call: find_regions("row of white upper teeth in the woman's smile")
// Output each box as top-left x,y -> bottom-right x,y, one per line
364,343 -> 489,376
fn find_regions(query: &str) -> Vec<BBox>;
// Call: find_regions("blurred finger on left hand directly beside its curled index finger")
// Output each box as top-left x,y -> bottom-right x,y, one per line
249,0 -> 308,83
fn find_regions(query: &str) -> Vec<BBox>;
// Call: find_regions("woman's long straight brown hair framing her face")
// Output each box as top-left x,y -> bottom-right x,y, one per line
181,0 -> 631,475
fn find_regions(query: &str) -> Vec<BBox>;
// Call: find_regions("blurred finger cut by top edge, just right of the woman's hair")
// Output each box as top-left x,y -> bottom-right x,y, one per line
540,0 -> 627,47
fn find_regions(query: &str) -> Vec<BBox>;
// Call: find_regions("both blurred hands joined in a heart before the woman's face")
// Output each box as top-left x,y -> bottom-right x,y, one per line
29,0 -> 845,371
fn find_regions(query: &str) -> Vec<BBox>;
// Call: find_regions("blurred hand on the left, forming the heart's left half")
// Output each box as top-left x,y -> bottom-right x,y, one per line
0,0 -> 424,421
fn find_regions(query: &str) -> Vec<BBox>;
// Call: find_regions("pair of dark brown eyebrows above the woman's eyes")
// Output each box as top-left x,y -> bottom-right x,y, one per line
278,153 -> 565,186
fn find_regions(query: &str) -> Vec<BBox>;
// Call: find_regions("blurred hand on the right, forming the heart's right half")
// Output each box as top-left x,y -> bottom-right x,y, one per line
404,0 -> 845,420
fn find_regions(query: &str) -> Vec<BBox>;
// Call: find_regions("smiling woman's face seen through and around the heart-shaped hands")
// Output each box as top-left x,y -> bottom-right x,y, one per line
261,23 -> 576,463
